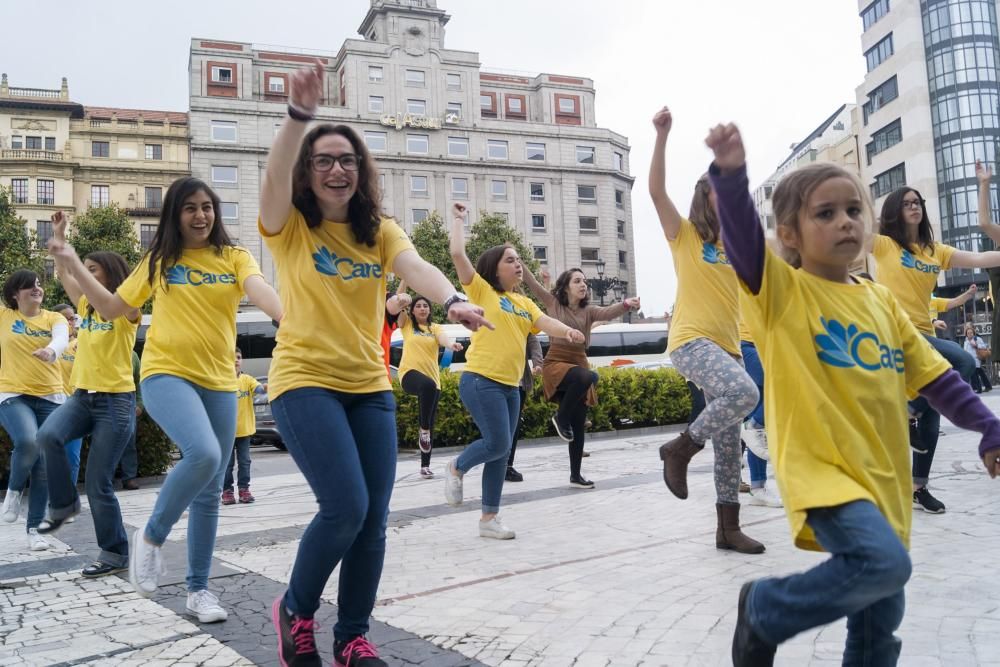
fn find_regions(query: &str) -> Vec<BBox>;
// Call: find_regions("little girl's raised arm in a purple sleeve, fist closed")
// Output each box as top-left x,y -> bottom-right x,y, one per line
705,123 -> 764,294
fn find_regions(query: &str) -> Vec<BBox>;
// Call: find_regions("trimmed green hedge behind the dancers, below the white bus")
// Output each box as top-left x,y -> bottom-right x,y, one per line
393,368 -> 691,448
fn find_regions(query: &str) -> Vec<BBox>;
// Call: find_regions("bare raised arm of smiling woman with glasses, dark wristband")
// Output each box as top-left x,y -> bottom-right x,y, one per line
260,60 -> 325,234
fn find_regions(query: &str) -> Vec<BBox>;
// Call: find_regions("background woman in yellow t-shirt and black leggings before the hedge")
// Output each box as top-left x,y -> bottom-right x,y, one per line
398,292 -> 463,479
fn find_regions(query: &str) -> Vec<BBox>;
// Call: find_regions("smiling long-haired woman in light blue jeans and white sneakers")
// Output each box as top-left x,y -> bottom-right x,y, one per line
49,177 -> 281,623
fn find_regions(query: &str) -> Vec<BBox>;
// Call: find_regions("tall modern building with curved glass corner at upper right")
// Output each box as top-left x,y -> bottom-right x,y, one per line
857,0 -> 1000,294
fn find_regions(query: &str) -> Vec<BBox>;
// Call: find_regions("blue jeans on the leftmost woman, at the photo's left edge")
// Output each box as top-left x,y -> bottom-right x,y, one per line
0,394 -> 59,529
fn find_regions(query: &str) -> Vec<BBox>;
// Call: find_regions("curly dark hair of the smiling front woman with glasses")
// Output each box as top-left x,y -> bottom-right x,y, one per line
292,123 -> 382,247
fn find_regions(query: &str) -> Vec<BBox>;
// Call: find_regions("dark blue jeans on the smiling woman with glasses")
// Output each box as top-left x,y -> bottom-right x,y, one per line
271,387 -> 396,641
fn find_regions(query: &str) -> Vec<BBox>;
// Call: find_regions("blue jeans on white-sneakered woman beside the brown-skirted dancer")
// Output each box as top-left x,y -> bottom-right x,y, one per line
455,371 -> 521,514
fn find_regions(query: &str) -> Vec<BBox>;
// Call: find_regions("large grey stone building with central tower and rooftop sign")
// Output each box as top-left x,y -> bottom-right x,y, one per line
190,0 -> 635,294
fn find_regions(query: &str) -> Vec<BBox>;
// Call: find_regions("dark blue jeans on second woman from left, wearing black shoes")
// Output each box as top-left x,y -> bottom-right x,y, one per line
37,389 -> 135,567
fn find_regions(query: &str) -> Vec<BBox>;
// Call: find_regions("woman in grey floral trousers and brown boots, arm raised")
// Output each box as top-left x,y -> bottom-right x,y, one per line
649,107 -> 764,554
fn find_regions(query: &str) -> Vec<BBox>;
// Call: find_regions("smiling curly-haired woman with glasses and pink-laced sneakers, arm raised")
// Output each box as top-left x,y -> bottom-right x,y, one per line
259,62 -> 489,667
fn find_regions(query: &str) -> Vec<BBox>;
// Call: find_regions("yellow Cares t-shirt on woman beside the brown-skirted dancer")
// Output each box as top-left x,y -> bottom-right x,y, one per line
463,273 -> 543,387
